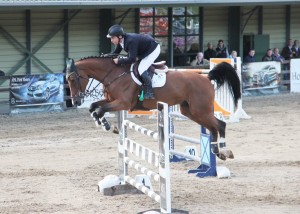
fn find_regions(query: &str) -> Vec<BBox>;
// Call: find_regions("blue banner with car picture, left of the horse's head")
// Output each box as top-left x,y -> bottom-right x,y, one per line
10,74 -> 64,113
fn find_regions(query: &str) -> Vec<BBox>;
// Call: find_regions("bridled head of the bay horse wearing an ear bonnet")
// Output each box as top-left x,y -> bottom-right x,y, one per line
66,58 -> 89,106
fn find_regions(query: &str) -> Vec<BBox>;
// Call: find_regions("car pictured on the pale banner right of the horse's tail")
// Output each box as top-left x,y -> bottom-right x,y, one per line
252,65 -> 278,86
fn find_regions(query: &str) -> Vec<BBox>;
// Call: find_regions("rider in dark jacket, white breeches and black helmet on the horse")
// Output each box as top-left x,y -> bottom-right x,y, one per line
107,25 -> 160,99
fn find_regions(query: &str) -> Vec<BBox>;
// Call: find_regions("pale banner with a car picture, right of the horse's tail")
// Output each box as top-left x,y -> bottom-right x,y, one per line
242,61 -> 281,95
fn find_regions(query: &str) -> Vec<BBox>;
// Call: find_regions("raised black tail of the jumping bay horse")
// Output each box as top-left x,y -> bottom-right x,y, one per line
208,62 -> 241,106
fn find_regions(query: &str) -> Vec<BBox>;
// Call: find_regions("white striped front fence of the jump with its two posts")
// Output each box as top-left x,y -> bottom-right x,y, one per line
118,106 -> 171,213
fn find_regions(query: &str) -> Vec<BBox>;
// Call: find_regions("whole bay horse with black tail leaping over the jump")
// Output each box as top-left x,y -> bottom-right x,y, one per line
65,55 -> 241,160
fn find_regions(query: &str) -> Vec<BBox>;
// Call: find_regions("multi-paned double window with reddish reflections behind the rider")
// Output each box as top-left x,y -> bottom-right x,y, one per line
139,6 -> 200,66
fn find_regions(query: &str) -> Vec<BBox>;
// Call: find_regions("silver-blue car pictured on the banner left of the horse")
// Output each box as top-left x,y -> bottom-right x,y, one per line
27,75 -> 61,101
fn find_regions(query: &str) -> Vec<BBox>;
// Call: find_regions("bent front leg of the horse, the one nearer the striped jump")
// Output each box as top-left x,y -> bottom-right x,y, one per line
97,100 -> 131,131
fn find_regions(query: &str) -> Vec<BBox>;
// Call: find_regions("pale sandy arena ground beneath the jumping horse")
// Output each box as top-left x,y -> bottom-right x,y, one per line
0,94 -> 300,214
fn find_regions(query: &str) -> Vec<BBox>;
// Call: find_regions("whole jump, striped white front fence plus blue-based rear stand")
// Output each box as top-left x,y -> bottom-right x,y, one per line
98,102 -> 230,213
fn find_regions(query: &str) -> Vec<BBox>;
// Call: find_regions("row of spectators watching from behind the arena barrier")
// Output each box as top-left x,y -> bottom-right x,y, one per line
174,39 -> 300,66
